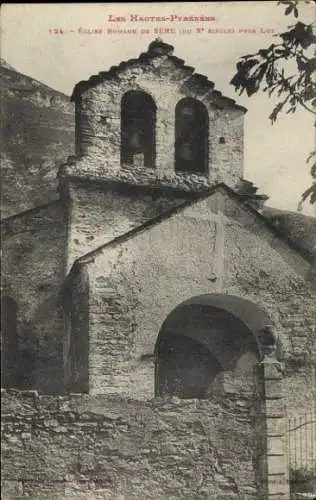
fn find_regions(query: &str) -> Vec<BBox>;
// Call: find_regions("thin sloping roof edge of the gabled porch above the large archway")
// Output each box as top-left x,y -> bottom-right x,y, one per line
73,183 -> 314,267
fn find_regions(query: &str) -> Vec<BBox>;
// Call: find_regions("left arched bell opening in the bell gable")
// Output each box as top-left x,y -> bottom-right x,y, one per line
121,91 -> 156,167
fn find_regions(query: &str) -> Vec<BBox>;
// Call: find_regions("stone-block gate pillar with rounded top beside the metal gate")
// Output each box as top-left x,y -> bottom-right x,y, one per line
258,356 -> 290,500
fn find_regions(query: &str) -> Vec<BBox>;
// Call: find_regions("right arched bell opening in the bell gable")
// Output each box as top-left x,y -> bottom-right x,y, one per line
175,98 -> 209,174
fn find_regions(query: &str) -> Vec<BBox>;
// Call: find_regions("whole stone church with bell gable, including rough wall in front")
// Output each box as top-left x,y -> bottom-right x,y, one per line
2,39 -> 316,500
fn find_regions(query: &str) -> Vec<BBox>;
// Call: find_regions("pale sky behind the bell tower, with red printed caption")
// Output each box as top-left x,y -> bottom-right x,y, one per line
1,1 -> 316,216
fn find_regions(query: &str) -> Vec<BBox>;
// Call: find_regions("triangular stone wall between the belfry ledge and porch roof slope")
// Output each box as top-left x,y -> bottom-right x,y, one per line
67,180 -> 186,270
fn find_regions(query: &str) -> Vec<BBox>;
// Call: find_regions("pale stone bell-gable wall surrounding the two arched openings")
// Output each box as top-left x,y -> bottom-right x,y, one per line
63,43 -> 246,189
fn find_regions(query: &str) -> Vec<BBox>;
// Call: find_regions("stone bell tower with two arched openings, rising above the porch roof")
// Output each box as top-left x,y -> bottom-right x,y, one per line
59,39 -> 260,268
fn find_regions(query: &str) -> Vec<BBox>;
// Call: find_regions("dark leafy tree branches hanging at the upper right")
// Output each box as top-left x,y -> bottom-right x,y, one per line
230,0 -> 316,205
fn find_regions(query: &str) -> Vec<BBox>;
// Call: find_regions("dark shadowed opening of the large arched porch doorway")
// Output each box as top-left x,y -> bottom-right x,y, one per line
156,301 -> 260,398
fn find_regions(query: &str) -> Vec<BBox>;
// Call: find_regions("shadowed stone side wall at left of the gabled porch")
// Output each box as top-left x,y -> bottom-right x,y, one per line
1,201 -> 67,392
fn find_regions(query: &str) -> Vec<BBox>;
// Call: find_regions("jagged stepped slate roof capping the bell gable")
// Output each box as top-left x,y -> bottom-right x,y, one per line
71,38 -> 247,112
